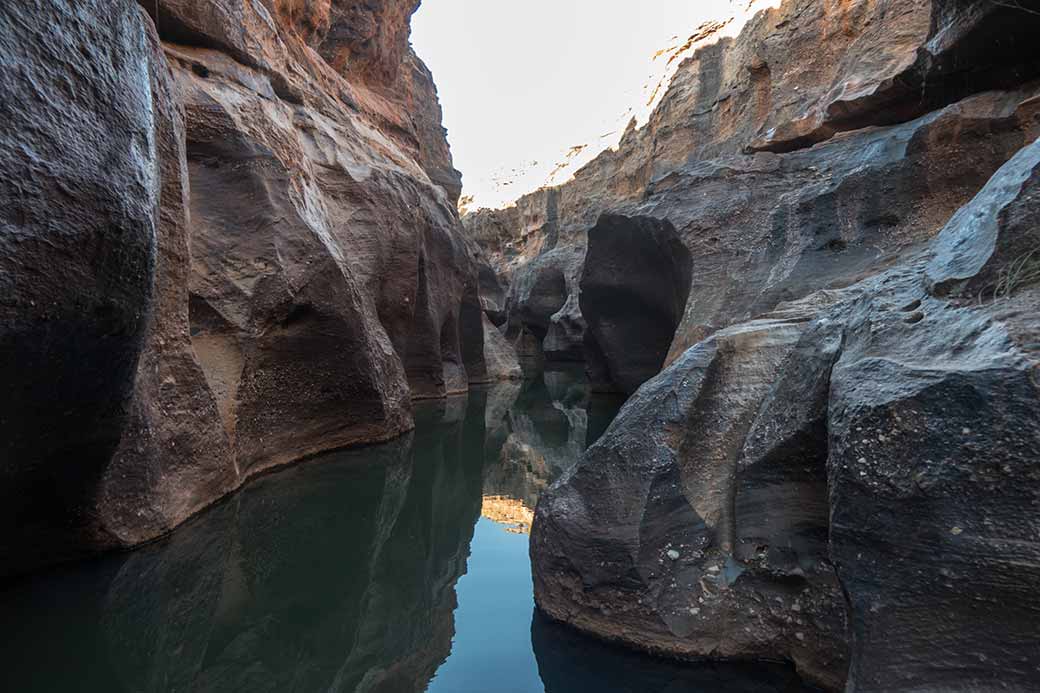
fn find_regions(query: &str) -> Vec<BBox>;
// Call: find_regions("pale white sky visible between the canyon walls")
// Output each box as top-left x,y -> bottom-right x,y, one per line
412,0 -> 731,208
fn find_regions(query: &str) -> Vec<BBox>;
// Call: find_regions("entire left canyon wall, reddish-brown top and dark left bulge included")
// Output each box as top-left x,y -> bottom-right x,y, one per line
0,0 -> 482,572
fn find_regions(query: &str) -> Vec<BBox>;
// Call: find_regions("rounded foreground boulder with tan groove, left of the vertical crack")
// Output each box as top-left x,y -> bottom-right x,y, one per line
531,304 -> 848,689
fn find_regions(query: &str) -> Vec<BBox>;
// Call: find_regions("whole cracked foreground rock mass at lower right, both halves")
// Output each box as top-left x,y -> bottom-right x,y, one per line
531,137 -> 1040,691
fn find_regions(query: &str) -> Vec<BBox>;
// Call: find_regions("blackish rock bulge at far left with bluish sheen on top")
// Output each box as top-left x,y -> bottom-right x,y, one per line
0,0 -> 164,572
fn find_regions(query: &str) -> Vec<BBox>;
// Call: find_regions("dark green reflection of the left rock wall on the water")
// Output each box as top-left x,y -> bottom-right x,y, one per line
4,401 -> 484,693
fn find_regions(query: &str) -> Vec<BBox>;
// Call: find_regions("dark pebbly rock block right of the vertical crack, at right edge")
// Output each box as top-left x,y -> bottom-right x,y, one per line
829,137 -> 1040,691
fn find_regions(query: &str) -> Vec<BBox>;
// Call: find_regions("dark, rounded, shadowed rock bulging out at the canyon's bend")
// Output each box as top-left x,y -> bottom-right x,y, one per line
578,214 -> 691,393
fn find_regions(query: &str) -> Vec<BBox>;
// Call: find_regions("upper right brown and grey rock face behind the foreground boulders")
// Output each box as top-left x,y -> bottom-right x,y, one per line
464,0 -> 1040,380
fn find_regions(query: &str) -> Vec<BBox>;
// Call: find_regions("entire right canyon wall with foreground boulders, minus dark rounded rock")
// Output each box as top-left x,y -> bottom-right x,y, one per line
515,0 -> 1040,691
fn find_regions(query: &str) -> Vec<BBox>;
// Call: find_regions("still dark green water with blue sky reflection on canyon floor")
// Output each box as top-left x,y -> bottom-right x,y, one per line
0,373 -> 802,693
